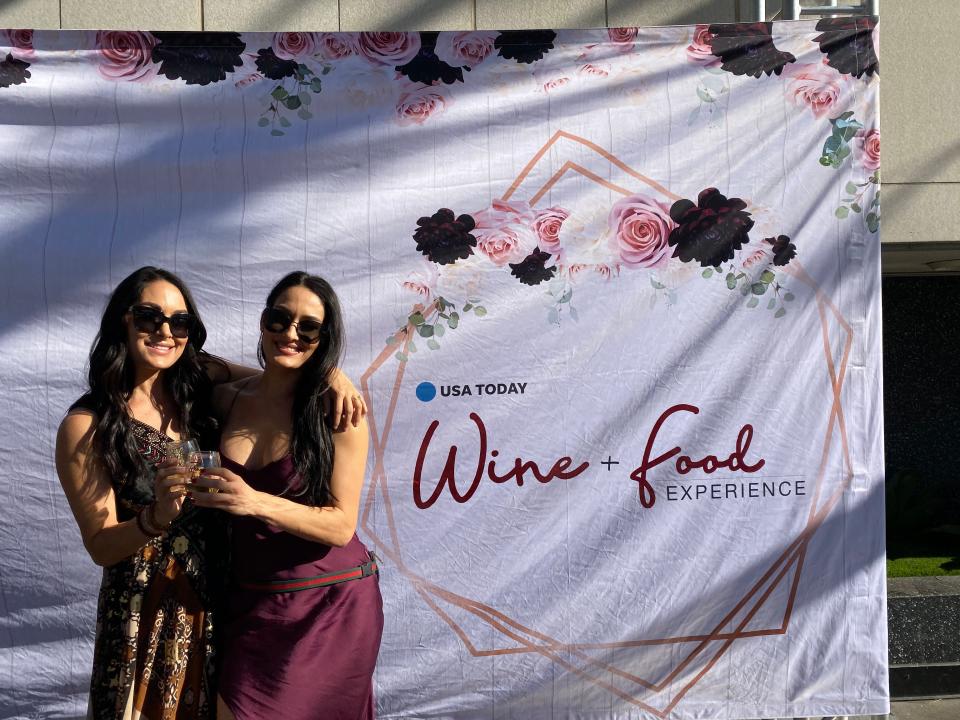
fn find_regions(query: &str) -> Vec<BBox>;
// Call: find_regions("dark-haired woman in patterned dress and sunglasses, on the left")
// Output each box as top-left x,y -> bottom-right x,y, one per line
56,267 -> 364,720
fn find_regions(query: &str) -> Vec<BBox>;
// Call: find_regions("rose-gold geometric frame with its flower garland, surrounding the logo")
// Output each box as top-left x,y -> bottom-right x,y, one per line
361,131 -> 853,718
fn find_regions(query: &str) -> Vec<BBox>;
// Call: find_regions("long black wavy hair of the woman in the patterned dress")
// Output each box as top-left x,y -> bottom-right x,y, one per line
75,266 -> 216,492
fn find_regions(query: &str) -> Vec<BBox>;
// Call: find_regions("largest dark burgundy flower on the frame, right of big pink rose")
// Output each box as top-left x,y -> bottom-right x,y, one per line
667,188 -> 753,267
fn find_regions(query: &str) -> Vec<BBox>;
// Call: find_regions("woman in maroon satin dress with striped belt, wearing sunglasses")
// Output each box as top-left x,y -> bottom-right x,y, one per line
193,272 -> 383,720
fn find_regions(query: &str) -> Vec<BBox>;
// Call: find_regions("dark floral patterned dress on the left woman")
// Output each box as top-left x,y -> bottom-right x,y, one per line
87,419 -> 227,720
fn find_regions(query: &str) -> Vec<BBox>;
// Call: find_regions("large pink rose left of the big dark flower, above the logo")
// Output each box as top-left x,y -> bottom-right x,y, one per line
608,194 -> 676,268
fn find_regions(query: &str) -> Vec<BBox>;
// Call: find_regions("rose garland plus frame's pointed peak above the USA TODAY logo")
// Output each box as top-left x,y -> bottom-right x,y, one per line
387,131 -> 797,359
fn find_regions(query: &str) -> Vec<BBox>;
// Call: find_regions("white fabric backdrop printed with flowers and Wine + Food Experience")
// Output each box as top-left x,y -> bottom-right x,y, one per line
0,18 -> 888,719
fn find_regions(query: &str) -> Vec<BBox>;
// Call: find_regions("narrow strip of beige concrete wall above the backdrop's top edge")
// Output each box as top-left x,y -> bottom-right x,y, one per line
0,0 -> 744,31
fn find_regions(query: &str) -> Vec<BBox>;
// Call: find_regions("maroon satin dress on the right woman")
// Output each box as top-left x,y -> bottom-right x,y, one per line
219,455 -> 383,720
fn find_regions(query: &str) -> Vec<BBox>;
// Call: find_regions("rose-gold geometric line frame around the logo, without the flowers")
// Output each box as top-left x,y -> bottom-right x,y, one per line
360,131 -> 853,718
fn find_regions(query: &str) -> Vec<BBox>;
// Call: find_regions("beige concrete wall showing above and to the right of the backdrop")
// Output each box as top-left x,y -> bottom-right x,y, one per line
0,0 -> 960,272
